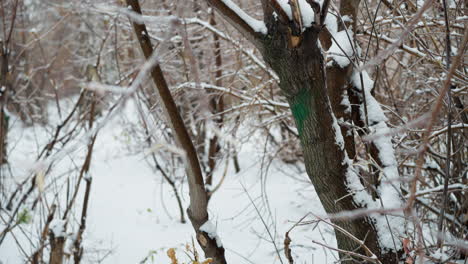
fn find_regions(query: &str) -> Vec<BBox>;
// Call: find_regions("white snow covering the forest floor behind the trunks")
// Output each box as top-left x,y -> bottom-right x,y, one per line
0,99 -> 336,264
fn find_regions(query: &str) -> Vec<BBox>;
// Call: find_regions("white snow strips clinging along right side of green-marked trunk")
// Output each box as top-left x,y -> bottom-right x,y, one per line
326,69 -> 405,250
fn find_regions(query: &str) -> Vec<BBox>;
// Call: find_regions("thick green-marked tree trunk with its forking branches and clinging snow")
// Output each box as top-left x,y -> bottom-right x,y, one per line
208,0 -> 399,263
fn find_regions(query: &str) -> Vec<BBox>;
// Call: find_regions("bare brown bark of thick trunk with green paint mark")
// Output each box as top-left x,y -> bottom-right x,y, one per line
263,22 -> 394,263
